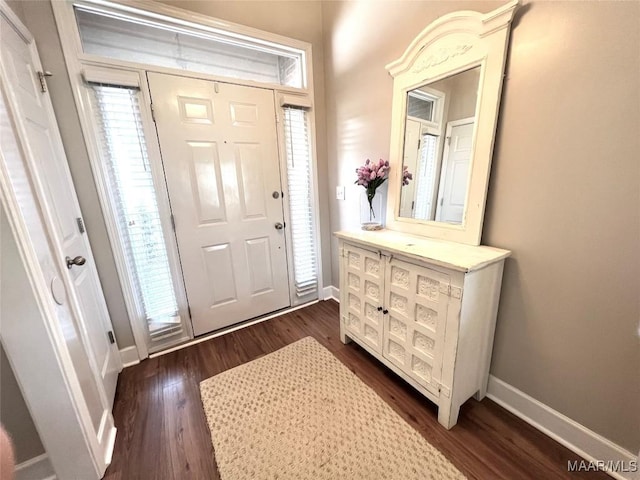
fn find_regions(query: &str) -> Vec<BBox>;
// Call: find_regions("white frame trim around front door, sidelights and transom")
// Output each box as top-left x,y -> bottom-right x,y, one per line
52,0 -> 325,359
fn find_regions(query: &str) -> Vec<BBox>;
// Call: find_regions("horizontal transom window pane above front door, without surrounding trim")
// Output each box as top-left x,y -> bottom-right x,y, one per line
74,4 -> 306,88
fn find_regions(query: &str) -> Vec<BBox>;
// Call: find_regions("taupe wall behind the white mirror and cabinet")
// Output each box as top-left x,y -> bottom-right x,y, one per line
322,1 -> 640,452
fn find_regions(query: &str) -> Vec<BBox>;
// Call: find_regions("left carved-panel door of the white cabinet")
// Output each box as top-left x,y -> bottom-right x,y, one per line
340,244 -> 386,352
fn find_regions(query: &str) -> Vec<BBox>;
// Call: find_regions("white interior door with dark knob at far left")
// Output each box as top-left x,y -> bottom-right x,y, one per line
0,13 -> 122,410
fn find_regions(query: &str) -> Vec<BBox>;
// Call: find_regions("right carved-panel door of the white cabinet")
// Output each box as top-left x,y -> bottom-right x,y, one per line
383,258 -> 449,395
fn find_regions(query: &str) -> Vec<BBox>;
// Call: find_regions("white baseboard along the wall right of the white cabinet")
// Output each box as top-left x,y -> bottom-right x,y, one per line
487,375 -> 637,480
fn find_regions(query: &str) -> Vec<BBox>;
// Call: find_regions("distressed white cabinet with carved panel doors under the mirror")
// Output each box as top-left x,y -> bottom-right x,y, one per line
336,230 -> 510,428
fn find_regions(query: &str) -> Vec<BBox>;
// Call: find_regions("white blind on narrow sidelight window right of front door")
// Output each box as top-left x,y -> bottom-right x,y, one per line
283,106 -> 318,298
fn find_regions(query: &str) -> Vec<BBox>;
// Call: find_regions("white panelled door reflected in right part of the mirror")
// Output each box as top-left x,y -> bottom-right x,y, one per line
436,118 -> 474,223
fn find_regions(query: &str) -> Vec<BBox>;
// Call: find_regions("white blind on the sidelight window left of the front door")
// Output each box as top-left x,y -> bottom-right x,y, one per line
91,84 -> 182,339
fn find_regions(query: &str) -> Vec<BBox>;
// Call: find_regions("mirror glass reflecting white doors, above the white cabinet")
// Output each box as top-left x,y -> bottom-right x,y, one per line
399,67 -> 480,224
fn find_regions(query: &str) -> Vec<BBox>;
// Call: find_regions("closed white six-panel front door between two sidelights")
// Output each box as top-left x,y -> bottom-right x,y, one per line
148,73 -> 290,335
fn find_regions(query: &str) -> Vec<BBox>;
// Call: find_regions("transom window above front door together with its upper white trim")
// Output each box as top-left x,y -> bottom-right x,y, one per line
58,0 -> 310,90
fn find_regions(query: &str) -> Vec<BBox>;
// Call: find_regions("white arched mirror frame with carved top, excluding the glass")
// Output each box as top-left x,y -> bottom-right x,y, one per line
386,0 -> 519,245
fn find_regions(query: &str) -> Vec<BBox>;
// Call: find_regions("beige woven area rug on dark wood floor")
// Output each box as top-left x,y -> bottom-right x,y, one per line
200,337 -> 465,480
